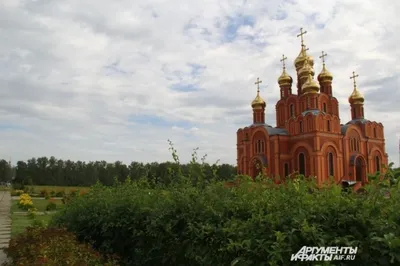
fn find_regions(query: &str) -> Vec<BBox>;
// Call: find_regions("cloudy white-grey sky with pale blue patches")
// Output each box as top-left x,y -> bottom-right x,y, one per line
0,0 -> 400,164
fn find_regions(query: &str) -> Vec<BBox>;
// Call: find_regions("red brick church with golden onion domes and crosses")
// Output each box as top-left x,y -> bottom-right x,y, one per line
237,29 -> 388,185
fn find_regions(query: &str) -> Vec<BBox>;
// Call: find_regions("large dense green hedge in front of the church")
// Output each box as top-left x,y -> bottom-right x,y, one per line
53,172 -> 400,265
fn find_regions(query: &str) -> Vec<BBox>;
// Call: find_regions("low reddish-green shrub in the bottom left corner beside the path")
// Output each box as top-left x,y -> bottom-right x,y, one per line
4,226 -> 118,266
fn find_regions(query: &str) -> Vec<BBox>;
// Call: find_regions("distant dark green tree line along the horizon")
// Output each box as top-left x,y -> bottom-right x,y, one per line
0,156 -> 236,186
